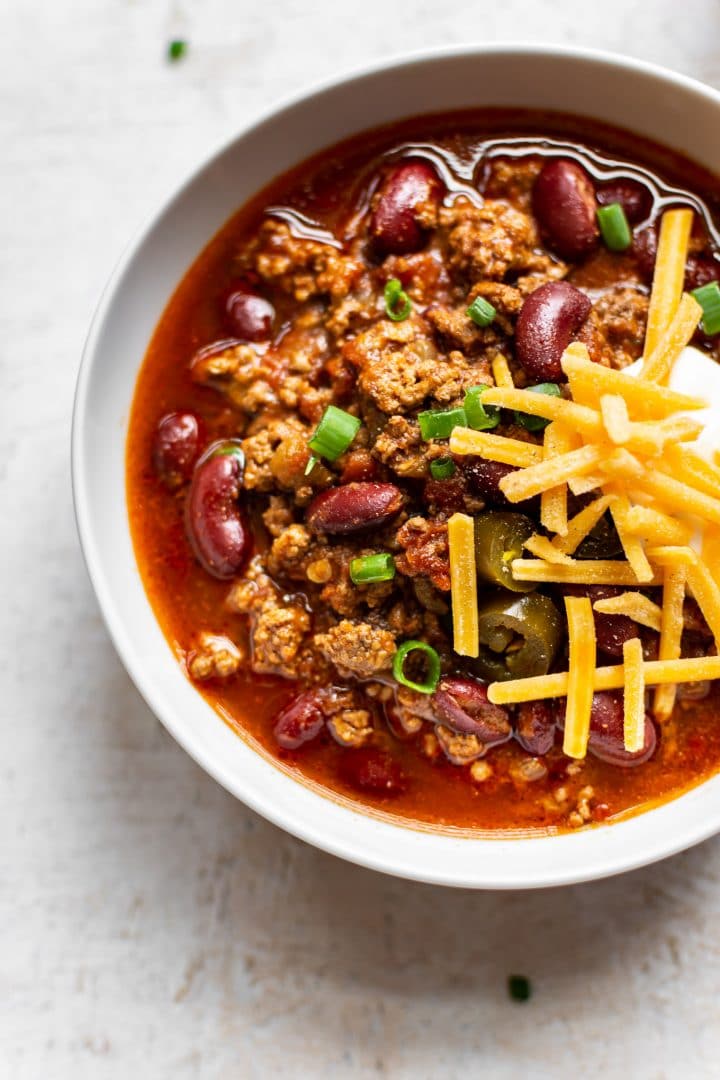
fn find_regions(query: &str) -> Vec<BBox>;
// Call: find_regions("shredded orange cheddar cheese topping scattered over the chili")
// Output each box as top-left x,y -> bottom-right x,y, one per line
449,210 -> 720,758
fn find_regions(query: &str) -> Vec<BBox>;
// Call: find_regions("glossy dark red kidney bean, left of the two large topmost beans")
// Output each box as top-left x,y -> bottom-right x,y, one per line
370,161 -> 445,255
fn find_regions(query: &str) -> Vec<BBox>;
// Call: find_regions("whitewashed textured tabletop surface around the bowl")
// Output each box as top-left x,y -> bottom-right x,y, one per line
0,0 -> 720,1080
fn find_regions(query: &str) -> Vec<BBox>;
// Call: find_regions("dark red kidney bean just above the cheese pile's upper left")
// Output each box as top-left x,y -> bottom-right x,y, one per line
515,281 -> 592,382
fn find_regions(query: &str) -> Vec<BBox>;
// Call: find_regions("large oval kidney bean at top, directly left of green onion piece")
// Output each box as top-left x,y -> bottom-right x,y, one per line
532,158 -> 599,259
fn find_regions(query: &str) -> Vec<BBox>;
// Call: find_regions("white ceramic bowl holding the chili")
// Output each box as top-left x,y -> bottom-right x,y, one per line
72,45 -> 720,889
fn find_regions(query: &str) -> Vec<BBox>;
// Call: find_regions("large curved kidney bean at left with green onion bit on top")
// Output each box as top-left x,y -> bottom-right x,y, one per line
185,440 -> 250,579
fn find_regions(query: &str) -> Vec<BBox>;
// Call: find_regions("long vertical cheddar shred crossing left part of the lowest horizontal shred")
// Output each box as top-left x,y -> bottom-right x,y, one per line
562,596 -> 595,758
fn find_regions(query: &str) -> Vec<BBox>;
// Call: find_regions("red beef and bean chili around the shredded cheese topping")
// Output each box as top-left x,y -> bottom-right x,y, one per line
127,110 -> 720,832
